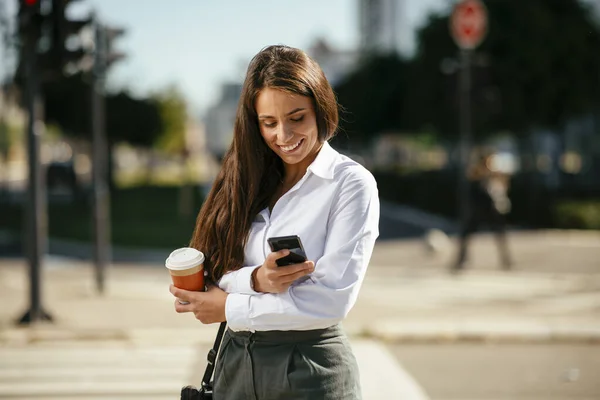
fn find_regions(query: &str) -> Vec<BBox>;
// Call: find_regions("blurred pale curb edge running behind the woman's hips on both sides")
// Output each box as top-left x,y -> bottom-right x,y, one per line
0,321 -> 600,346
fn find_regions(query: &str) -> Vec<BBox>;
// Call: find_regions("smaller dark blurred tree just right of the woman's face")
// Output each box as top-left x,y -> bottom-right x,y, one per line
335,54 -> 407,144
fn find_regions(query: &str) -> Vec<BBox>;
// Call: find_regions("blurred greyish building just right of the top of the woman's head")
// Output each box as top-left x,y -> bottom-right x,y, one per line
307,39 -> 360,86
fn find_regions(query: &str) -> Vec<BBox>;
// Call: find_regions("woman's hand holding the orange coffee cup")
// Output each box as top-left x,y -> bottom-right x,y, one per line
169,285 -> 227,324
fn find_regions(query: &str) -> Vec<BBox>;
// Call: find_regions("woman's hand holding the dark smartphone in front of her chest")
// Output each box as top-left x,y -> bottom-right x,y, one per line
252,249 -> 315,293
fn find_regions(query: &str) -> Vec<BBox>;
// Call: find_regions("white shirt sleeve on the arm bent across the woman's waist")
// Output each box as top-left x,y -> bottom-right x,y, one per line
225,167 -> 379,331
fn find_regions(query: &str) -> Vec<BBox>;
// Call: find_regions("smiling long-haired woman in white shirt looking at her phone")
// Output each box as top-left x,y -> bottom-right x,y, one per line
171,46 -> 379,400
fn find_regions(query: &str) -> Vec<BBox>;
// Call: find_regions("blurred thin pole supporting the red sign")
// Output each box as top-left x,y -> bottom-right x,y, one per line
458,49 -> 471,229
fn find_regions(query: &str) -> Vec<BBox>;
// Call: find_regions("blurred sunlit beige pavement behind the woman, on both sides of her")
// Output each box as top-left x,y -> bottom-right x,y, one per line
0,232 -> 600,342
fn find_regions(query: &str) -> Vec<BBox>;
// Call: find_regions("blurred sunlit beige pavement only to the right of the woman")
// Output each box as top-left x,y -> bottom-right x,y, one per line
358,231 -> 600,342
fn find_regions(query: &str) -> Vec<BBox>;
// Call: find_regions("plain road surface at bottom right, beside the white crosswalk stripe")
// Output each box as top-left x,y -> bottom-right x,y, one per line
390,343 -> 600,400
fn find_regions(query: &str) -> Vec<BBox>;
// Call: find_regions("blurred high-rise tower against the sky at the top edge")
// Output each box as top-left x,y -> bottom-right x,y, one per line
358,0 -> 409,55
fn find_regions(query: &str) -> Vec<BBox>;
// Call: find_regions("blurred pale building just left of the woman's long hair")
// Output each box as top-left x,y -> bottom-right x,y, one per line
204,83 -> 242,159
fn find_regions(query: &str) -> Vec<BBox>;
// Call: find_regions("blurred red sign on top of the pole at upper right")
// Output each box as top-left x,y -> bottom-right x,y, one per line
450,0 -> 487,50
